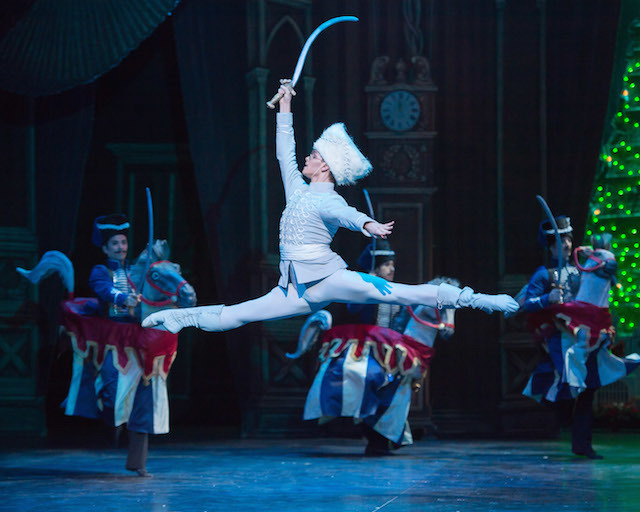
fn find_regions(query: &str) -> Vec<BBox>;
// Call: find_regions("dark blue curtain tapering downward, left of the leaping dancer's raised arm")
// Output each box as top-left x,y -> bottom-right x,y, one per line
173,0 -> 241,291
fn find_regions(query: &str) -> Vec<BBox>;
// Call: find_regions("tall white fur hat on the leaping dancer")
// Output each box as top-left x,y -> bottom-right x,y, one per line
313,123 -> 373,185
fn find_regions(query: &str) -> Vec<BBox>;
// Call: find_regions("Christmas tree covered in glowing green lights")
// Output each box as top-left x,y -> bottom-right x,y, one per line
586,20 -> 640,335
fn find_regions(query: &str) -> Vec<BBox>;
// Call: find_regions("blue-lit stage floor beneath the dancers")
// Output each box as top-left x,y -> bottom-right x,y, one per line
0,433 -> 640,512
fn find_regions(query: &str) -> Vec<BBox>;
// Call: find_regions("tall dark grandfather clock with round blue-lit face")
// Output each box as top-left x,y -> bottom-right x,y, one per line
365,55 -> 438,428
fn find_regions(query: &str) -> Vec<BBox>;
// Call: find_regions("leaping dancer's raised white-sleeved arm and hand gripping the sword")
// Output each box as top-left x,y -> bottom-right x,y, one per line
276,81 -> 305,200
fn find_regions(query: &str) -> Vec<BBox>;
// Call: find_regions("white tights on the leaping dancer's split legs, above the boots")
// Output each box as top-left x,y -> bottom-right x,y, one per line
220,270 -> 438,331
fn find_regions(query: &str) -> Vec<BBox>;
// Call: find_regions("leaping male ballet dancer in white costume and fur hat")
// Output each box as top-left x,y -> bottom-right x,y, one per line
142,81 -> 519,333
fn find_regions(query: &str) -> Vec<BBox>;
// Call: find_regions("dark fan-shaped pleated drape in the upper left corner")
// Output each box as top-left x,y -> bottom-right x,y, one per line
0,0 -> 179,96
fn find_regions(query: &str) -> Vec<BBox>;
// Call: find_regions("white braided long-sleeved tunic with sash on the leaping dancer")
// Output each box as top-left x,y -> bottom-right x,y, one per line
276,113 -> 373,289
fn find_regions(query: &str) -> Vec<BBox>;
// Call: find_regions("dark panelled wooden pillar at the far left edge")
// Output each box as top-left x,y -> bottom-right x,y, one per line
0,93 -> 46,439
